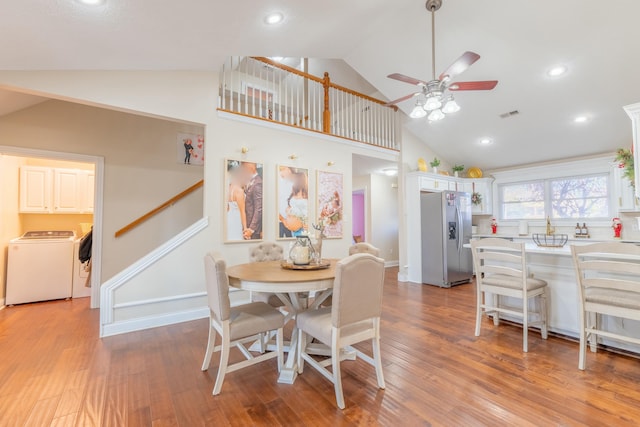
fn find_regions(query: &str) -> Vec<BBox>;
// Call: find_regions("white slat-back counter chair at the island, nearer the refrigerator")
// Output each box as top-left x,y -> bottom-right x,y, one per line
471,238 -> 548,352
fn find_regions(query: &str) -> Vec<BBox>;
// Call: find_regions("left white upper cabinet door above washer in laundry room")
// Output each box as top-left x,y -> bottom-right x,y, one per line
20,166 -> 52,213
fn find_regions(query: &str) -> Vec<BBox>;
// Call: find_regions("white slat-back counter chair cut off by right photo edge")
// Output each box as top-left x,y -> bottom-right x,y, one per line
571,246 -> 640,370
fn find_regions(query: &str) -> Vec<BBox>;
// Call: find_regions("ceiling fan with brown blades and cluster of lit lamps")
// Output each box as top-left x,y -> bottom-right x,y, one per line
387,0 -> 498,121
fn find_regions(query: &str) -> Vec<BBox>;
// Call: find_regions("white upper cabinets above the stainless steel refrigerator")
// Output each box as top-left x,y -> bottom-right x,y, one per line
407,172 -> 493,215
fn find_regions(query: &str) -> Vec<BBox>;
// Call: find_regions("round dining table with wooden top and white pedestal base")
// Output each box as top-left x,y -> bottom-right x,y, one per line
227,259 -> 338,384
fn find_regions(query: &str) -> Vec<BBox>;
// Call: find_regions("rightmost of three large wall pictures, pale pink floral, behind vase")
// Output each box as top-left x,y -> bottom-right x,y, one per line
316,171 -> 344,239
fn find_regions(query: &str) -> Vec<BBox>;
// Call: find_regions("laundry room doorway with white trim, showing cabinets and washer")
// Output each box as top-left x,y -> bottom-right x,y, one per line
0,146 -> 104,308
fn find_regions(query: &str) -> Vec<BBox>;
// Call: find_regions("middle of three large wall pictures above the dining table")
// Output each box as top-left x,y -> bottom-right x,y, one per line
276,165 -> 309,240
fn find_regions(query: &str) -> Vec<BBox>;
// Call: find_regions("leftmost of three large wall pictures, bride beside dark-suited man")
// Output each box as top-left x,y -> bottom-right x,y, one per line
223,159 -> 264,242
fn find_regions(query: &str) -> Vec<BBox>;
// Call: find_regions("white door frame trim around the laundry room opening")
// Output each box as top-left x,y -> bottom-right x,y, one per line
0,145 -> 104,308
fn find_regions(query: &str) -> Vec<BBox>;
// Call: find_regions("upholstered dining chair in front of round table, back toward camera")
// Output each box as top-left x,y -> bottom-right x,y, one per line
296,254 -> 385,409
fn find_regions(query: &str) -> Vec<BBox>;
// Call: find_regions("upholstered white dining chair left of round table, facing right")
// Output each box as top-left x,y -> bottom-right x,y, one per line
202,254 -> 284,396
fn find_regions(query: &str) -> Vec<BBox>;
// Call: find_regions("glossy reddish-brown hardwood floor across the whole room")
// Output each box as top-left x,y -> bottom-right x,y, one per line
0,269 -> 640,427
